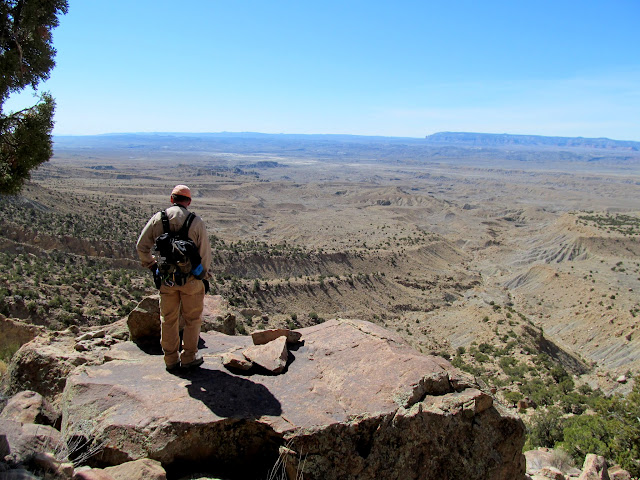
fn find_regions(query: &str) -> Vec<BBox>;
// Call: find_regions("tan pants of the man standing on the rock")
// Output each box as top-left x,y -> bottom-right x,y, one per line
160,277 -> 204,365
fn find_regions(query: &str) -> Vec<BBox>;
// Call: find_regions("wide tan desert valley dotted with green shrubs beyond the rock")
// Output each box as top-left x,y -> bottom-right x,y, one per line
0,133 -> 640,472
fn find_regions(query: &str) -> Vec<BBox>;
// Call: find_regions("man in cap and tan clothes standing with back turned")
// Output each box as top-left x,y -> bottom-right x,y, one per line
136,185 -> 211,372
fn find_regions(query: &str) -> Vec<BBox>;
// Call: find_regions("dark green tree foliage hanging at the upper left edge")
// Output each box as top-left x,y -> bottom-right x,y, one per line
0,0 -> 68,194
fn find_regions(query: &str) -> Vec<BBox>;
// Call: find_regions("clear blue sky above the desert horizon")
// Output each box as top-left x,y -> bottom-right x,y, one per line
8,0 -> 640,141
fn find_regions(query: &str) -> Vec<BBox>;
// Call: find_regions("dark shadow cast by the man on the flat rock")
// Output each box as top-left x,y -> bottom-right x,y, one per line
176,368 -> 282,419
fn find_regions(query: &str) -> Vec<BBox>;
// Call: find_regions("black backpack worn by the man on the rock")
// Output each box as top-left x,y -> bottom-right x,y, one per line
154,210 -> 205,286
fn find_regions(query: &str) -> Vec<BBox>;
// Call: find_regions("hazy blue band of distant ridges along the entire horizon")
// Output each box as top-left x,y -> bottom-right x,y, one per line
54,132 -> 640,169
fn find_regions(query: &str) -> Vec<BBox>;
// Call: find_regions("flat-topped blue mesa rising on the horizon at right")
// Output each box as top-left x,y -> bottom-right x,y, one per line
425,132 -> 640,151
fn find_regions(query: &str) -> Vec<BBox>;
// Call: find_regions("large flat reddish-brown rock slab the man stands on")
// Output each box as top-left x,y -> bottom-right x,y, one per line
62,320 -> 525,480
